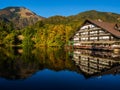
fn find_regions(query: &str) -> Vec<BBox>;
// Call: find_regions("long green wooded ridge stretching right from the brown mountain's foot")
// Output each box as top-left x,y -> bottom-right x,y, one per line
45,10 -> 120,24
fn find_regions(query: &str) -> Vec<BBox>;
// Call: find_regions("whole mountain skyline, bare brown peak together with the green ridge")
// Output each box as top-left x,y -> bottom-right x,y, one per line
0,7 -> 120,29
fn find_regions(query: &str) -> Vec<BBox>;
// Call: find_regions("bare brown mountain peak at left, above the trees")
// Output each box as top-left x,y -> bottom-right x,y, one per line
0,7 -> 44,29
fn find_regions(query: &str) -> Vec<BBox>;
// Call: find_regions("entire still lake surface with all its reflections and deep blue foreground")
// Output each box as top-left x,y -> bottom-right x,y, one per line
0,48 -> 120,90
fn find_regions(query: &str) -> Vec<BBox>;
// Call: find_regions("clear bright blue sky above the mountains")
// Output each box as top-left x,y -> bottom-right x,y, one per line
0,0 -> 120,17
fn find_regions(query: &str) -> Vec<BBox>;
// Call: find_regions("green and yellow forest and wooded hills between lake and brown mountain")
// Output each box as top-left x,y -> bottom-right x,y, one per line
0,9 -> 120,47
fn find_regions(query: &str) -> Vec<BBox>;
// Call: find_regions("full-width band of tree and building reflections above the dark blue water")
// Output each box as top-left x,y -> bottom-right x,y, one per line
0,47 -> 120,79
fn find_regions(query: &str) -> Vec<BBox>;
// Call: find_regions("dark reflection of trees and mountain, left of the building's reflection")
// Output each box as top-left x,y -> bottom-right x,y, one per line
0,48 -> 79,79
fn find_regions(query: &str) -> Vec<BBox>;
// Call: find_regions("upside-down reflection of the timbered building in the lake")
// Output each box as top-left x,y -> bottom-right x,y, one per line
73,49 -> 120,78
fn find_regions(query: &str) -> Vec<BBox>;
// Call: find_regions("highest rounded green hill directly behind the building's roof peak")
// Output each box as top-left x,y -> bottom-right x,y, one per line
67,10 -> 120,22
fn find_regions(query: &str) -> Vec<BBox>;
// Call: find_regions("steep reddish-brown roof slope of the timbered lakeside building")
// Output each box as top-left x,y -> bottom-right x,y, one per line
83,20 -> 120,38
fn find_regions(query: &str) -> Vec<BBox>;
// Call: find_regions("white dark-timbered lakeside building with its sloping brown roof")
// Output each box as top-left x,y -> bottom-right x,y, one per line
70,20 -> 120,50
